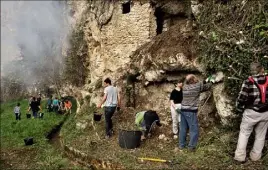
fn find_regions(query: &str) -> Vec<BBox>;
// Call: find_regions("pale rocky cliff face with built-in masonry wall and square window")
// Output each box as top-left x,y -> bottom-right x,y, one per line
69,0 -> 234,125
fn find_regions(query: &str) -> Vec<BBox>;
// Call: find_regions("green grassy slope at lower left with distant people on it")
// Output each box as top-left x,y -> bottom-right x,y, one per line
0,97 -> 82,169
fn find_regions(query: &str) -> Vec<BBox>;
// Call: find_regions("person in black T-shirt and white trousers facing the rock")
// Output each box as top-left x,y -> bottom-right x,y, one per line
169,79 -> 183,139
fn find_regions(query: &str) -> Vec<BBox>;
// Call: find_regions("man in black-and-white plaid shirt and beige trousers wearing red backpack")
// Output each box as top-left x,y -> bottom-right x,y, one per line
234,63 -> 268,163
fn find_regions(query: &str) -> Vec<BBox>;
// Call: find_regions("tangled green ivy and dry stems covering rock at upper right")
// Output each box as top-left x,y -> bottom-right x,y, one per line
196,0 -> 268,97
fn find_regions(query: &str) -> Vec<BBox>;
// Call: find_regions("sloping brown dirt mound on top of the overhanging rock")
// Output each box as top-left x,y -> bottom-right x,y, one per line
131,20 -> 196,73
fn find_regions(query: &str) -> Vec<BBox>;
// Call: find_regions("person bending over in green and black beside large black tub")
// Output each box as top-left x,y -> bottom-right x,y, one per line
135,110 -> 162,140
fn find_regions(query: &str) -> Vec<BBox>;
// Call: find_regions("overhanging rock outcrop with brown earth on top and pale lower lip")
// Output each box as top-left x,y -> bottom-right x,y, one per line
129,20 -> 200,82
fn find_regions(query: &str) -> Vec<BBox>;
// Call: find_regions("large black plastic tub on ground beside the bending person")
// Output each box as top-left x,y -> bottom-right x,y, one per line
118,129 -> 142,149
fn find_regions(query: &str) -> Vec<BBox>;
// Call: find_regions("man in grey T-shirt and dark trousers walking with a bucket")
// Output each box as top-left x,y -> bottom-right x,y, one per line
98,78 -> 120,138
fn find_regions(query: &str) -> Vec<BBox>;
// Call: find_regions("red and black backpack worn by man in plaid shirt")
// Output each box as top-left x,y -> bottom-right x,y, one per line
248,76 -> 268,113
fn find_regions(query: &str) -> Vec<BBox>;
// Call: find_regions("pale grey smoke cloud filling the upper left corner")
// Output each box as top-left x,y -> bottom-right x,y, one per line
1,1 -> 71,85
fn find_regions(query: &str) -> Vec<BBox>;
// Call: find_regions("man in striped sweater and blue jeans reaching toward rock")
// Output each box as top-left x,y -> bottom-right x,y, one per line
179,74 -> 212,151
